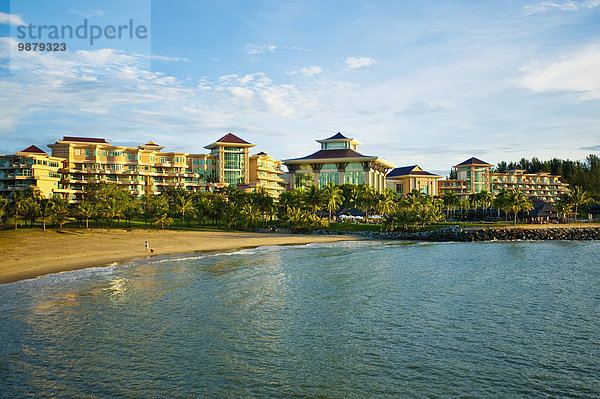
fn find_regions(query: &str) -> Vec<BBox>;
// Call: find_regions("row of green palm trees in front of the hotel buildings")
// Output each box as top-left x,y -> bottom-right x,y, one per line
0,183 -> 593,232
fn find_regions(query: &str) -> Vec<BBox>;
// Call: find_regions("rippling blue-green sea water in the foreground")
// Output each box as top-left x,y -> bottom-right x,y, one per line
0,242 -> 600,398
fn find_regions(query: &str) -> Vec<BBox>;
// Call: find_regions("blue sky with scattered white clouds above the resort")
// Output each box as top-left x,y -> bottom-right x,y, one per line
0,0 -> 600,175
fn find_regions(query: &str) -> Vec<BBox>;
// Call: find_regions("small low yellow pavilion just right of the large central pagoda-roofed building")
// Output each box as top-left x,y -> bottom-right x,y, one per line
385,165 -> 442,196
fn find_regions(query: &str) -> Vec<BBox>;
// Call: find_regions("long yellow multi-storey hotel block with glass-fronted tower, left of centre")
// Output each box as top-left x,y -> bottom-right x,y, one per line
49,133 -> 283,202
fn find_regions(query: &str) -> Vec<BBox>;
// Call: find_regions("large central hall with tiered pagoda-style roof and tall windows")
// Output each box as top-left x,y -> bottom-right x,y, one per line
283,132 -> 394,191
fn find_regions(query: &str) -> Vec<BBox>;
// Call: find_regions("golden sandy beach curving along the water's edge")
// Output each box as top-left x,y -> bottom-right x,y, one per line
0,229 -> 356,283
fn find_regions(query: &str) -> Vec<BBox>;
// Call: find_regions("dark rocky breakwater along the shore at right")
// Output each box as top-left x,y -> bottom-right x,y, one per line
313,226 -> 600,241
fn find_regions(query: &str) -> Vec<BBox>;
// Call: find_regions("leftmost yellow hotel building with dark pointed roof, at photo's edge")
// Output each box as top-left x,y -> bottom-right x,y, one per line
0,145 -> 64,198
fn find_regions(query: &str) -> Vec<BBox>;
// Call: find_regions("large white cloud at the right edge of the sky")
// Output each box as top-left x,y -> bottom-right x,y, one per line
519,45 -> 600,99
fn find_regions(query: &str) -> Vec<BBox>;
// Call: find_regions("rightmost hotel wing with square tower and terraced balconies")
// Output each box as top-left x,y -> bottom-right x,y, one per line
438,158 -> 568,203
